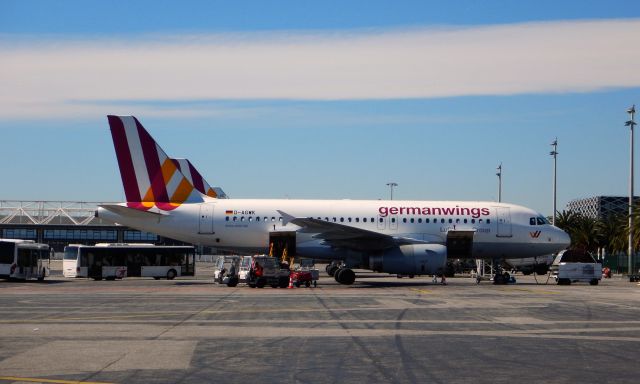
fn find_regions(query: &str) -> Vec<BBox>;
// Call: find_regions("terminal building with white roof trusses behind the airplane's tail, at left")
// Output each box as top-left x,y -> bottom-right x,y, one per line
0,200 -> 185,252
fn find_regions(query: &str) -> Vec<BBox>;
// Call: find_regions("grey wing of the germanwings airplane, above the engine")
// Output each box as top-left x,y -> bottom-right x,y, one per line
278,211 -> 429,251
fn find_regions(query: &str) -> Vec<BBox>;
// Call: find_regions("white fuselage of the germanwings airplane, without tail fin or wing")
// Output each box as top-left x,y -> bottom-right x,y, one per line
98,199 -> 570,259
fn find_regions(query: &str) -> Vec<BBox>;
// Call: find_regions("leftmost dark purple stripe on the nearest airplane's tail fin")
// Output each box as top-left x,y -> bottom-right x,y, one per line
107,115 -> 142,202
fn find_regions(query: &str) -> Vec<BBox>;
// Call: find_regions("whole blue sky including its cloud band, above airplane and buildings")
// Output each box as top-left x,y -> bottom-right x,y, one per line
0,1 -> 640,214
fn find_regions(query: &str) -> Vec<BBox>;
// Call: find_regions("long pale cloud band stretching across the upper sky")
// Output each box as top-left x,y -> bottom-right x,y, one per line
0,19 -> 640,119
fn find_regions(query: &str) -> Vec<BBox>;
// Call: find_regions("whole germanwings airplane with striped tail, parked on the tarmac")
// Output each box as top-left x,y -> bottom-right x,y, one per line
96,115 -> 570,285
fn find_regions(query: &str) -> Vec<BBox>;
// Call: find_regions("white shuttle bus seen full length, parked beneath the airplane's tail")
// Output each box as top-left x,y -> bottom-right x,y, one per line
62,243 -> 195,280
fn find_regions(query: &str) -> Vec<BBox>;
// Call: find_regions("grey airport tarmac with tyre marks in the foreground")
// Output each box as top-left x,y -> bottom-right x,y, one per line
0,268 -> 640,384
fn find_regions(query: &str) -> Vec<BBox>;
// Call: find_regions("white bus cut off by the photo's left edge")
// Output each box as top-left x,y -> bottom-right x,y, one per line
0,239 -> 51,281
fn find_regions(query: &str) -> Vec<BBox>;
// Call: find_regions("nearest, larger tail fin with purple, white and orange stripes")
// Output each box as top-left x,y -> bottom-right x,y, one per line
107,115 -> 204,211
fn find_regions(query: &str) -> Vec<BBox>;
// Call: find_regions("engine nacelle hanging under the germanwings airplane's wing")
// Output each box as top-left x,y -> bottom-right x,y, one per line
369,244 -> 447,275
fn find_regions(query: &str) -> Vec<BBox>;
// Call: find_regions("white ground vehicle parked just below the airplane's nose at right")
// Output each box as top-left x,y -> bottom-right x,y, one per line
551,249 -> 602,285
